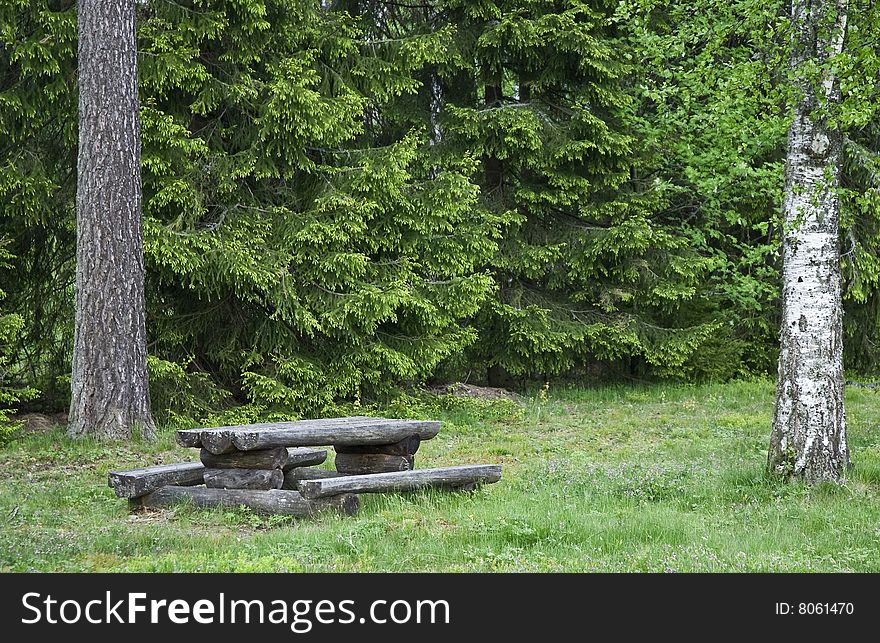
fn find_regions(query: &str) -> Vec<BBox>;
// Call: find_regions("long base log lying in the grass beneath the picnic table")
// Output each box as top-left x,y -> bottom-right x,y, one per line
140,486 -> 360,516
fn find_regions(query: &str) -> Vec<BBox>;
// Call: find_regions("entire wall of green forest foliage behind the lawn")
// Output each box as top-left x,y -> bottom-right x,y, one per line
0,0 -> 880,424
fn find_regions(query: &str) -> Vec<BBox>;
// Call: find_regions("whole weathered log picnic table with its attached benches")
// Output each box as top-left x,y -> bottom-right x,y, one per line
108,416 -> 501,516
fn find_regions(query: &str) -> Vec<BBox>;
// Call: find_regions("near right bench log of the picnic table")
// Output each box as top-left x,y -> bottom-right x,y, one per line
299,464 -> 501,498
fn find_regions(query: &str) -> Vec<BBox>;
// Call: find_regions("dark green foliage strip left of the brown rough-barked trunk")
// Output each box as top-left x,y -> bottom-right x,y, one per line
0,0 -> 77,397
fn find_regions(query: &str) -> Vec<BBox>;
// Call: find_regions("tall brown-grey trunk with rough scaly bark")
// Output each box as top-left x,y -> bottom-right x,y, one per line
68,0 -> 155,439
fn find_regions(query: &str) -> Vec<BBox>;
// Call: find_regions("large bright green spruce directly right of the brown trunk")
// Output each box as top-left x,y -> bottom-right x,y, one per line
141,1 -> 497,413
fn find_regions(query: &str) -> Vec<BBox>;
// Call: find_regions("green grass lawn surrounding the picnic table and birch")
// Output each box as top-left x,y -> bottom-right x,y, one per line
0,382 -> 880,572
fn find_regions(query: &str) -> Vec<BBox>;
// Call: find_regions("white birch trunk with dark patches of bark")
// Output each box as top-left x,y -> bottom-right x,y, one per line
768,0 -> 849,483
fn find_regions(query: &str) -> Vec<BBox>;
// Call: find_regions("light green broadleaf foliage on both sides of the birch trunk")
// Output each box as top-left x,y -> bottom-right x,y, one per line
617,0 -> 880,379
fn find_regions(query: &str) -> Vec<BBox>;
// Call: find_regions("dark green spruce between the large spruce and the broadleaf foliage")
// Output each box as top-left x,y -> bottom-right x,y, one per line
438,0 -> 712,376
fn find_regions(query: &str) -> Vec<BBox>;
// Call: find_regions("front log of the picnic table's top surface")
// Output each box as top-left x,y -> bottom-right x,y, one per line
232,419 -> 440,451
